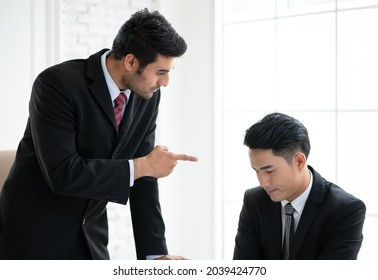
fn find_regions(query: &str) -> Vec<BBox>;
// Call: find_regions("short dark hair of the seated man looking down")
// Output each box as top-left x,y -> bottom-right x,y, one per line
244,113 -> 311,163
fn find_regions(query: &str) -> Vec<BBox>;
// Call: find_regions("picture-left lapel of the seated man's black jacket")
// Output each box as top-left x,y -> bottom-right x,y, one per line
263,201 -> 282,260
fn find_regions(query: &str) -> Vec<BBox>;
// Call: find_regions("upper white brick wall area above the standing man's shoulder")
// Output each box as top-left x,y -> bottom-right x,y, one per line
60,0 -> 155,60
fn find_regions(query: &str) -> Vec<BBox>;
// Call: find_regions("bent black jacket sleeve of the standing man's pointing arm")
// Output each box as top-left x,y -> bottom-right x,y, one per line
29,68 -> 130,204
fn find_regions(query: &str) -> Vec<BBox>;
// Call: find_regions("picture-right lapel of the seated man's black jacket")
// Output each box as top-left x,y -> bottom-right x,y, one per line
290,168 -> 323,259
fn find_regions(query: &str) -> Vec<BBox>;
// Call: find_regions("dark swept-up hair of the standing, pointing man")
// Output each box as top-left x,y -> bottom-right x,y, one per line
112,9 -> 187,70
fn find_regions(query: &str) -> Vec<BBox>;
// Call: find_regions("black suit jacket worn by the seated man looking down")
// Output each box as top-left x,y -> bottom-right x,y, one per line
234,167 -> 366,260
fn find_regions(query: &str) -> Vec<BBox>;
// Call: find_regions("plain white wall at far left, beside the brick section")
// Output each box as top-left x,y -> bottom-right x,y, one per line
0,0 -> 59,150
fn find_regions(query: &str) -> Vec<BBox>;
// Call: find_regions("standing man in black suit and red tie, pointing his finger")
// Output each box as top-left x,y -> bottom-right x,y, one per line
0,9 -> 197,259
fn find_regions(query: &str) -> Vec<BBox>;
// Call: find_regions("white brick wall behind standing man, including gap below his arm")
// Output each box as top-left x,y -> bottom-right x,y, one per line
60,0 -> 155,259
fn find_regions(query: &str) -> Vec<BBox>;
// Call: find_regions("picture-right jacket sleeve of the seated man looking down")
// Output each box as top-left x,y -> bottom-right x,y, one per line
318,198 -> 366,260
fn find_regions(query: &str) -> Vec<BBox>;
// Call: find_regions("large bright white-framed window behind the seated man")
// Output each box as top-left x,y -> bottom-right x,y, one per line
217,0 -> 378,259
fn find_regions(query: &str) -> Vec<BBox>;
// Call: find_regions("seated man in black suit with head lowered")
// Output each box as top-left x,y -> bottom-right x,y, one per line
234,113 -> 366,260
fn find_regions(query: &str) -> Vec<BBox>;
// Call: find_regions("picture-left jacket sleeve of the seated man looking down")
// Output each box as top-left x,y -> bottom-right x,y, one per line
233,191 -> 263,260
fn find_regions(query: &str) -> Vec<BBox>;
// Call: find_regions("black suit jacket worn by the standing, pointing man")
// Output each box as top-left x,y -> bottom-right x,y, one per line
0,50 -> 167,259
